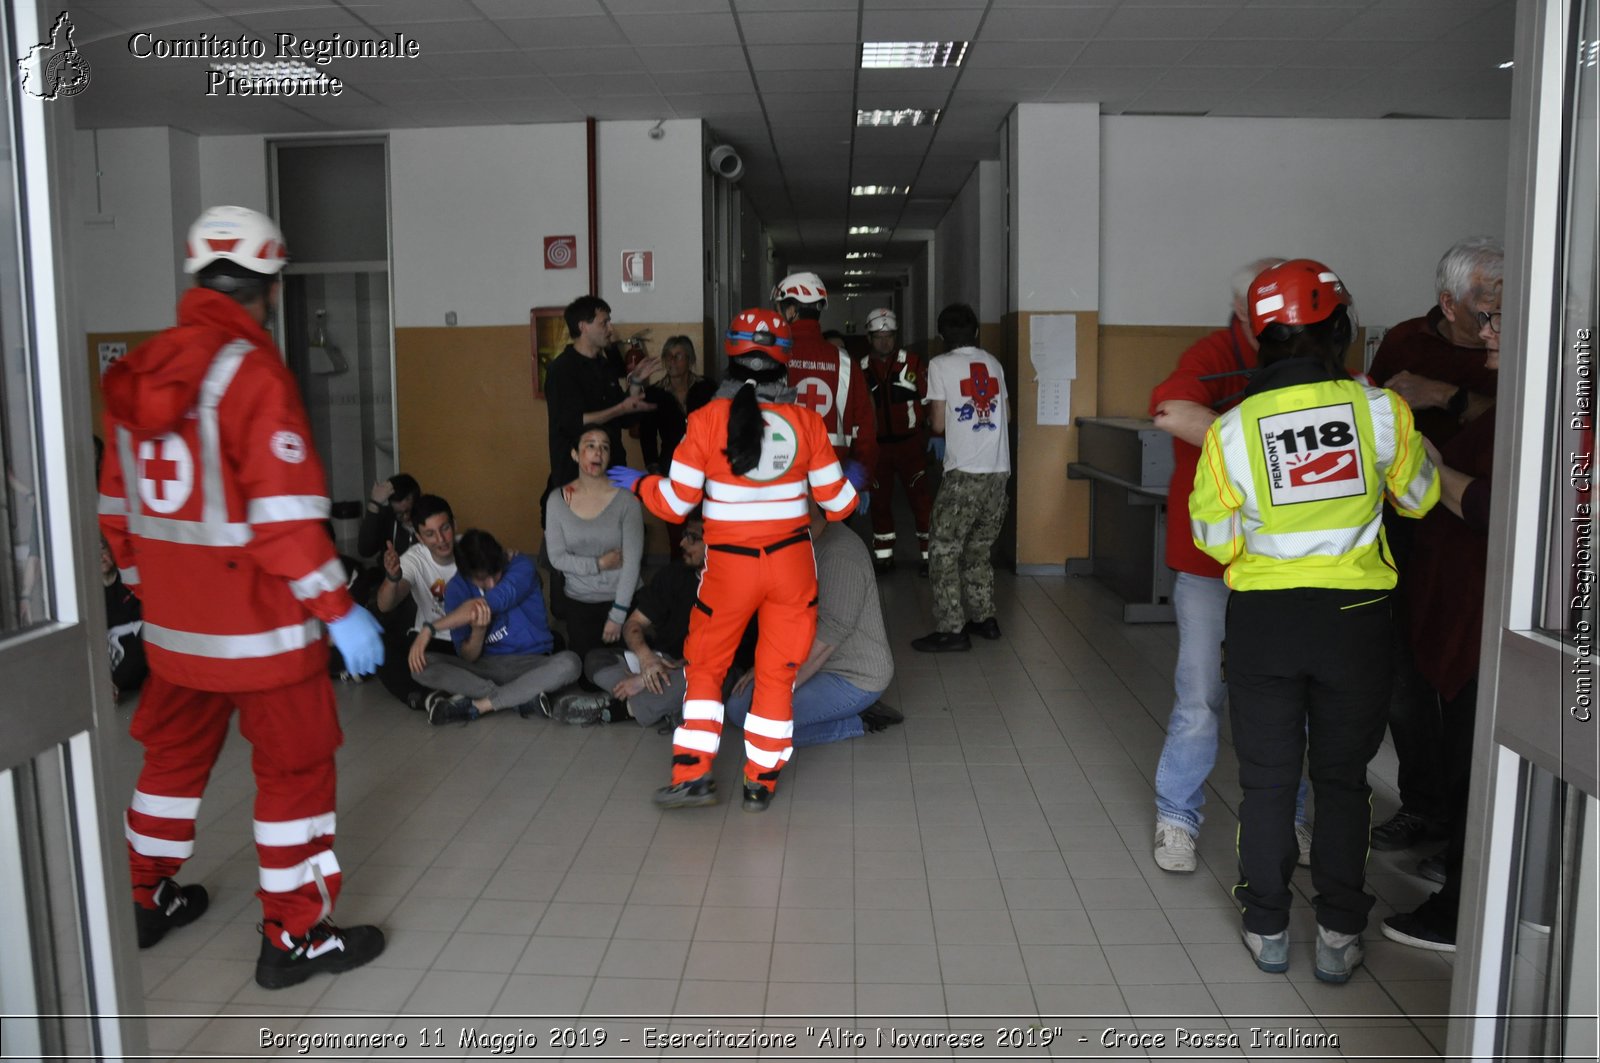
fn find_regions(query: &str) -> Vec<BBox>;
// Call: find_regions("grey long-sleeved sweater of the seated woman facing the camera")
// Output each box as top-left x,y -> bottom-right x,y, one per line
544,491 -> 645,624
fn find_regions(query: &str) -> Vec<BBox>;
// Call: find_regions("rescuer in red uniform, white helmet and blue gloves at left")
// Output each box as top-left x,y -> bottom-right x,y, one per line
99,207 -> 384,989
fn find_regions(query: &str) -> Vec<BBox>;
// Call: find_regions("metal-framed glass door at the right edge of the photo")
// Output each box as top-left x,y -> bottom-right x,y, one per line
1465,0 -> 1600,1060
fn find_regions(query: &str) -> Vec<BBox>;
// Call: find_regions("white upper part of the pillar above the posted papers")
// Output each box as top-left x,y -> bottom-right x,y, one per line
1006,104 -> 1101,311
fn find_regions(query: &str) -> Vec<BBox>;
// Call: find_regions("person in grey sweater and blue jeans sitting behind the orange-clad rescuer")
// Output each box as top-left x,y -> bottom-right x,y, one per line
728,503 -> 904,746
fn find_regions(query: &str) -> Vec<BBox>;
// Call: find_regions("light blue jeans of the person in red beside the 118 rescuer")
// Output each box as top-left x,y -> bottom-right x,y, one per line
1155,572 -> 1306,834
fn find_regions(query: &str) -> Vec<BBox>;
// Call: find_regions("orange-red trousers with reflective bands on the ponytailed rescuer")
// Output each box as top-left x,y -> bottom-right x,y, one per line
672,536 -> 816,789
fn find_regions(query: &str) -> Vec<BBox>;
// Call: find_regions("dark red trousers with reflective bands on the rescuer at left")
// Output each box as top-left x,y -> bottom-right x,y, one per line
126,674 -> 344,937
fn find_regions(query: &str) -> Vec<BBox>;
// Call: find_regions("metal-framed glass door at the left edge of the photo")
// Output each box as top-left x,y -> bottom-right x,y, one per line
0,3 -> 142,1058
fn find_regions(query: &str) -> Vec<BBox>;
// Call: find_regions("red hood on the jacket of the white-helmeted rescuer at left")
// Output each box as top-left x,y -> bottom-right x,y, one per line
101,288 -> 277,432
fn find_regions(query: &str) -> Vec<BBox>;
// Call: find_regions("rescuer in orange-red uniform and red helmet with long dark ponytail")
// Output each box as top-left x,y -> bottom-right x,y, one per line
608,309 -> 864,812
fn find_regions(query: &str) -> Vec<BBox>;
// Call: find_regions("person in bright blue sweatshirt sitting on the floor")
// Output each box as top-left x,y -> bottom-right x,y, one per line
408,528 -> 582,725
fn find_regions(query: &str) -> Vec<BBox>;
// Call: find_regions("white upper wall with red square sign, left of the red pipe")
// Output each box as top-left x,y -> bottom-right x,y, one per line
389,123 -> 603,328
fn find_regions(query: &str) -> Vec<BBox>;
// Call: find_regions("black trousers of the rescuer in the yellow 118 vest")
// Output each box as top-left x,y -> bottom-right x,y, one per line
1227,588 -> 1394,935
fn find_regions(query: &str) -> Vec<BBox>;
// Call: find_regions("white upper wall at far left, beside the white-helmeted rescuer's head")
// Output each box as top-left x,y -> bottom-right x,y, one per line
72,126 -> 183,333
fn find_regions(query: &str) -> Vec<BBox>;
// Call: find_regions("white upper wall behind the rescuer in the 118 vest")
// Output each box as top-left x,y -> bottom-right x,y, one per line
1101,117 -> 1507,325
